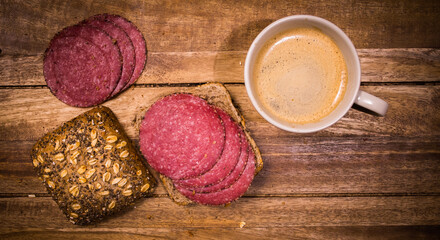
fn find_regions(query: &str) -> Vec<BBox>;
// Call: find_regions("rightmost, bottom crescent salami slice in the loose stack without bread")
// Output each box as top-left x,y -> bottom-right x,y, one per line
103,14 -> 147,89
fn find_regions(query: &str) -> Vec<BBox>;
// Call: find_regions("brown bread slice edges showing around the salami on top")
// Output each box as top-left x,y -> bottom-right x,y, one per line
139,83 -> 263,205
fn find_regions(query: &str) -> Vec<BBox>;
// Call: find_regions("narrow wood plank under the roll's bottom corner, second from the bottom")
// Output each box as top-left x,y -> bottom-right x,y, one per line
0,196 -> 440,230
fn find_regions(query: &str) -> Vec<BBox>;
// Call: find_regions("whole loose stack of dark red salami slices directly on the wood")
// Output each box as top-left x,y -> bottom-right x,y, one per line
43,14 -> 147,107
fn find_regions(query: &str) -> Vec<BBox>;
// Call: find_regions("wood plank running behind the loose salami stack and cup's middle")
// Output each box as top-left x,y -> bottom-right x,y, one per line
0,48 -> 440,86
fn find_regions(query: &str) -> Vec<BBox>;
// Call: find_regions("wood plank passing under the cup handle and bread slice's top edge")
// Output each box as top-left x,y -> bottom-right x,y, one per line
0,85 -> 440,141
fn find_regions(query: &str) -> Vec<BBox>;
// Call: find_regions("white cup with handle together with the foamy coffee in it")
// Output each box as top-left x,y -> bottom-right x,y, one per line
244,15 -> 388,133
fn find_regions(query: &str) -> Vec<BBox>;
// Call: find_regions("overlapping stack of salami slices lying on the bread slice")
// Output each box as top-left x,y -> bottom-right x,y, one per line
139,93 -> 256,205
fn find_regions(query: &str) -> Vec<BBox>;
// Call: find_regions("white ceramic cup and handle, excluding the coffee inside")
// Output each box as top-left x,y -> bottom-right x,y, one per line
244,15 -> 388,133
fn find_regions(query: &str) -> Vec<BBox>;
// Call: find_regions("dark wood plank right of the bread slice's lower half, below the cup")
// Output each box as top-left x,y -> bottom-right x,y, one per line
0,137 -> 440,196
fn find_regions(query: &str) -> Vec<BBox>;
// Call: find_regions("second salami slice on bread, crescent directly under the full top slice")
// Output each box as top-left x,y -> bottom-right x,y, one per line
174,108 -> 241,188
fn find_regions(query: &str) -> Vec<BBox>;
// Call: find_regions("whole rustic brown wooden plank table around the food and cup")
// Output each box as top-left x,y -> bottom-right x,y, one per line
0,0 -> 440,239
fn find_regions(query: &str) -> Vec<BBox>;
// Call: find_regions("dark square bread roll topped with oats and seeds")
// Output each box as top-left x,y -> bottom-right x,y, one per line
32,107 -> 156,225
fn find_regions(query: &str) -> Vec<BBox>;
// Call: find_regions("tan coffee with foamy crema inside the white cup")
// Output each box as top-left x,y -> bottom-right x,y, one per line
253,28 -> 347,124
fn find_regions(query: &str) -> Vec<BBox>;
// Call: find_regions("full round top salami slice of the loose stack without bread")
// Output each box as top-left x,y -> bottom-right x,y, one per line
43,36 -> 116,107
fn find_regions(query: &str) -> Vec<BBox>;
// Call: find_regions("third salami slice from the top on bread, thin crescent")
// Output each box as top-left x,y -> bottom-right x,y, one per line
176,132 -> 252,193
